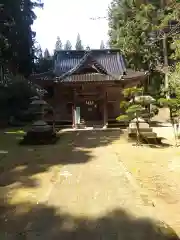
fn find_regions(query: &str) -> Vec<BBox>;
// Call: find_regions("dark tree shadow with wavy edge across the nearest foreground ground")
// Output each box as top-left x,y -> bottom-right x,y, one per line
0,202 -> 179,240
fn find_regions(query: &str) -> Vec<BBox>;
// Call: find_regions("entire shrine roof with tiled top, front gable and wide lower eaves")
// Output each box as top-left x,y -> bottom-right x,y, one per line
31,49 -> 146,83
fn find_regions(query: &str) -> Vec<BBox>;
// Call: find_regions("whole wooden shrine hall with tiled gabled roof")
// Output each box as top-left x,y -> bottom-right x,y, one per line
31,49 -> 147,128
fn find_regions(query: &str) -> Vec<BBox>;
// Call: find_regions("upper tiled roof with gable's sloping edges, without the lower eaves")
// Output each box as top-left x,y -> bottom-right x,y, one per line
54,49 -> 126,78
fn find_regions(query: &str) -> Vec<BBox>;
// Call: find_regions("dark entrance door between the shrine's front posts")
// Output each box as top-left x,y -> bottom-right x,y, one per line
81,100 -> 101,122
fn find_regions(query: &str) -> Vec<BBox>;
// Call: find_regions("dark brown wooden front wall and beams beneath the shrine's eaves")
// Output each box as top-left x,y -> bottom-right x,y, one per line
34,81 -> 123,123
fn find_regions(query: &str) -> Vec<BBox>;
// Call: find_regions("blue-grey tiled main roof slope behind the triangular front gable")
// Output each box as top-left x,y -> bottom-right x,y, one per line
54,50 -> 126,77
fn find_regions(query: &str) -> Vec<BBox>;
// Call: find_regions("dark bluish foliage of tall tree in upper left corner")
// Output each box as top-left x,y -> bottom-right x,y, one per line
0,0 -> 43,75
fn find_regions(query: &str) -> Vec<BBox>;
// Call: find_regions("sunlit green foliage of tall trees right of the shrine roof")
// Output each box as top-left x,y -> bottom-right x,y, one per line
109,0 -> 180,96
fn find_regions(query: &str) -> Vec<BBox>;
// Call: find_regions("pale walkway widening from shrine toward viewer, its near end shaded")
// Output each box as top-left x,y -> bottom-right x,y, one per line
26,138 -> 179,240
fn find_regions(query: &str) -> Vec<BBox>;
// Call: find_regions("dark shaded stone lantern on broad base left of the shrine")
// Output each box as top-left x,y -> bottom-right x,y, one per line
23,97 -> 57,144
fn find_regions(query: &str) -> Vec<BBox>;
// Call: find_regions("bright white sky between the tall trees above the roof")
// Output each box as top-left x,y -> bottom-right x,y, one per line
33,0 -> 111,52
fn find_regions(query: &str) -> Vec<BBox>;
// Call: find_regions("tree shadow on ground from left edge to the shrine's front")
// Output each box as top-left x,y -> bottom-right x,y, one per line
0,130 -> 122,187
